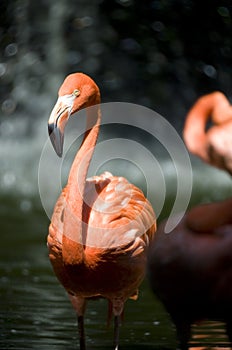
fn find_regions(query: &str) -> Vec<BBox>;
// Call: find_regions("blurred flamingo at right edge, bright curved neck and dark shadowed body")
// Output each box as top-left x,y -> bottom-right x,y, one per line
148,92 -> 232,350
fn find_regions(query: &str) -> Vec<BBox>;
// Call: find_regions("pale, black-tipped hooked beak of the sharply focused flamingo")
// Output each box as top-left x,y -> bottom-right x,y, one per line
48,95 -> 75,157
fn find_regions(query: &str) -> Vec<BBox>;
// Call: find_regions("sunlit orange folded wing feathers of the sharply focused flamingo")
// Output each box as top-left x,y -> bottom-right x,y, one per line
85,172 -> 155,249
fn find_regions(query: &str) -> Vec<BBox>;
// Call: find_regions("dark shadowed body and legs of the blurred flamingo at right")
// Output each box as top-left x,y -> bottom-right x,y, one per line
148,199 -> 232,350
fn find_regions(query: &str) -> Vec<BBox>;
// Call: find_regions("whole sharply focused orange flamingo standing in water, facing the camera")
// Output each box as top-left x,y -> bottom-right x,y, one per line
48,73 -> 156,350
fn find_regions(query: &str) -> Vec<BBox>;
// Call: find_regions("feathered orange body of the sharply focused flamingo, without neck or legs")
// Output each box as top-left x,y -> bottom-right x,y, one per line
48,173 -> 153,300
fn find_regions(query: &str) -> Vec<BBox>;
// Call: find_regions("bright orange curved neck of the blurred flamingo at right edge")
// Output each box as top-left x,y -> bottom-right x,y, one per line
183,91 -> 232,174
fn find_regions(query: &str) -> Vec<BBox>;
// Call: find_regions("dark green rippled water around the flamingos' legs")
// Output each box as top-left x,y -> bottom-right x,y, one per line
0,189 -> 232,350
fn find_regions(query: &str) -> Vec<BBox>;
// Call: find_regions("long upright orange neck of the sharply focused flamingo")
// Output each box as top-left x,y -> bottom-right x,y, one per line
62,105 -> 101,265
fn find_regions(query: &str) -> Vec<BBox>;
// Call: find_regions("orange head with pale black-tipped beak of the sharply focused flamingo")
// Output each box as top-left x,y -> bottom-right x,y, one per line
48,73 -> 100,157
